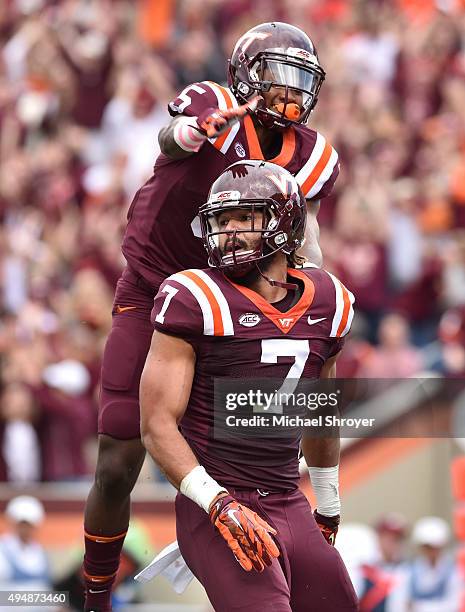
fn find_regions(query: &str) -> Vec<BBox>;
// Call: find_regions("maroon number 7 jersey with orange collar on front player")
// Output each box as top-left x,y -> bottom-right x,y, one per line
152,268 -> 354,490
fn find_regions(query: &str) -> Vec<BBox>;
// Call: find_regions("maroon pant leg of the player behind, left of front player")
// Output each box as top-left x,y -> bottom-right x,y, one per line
98,268 -> 156,440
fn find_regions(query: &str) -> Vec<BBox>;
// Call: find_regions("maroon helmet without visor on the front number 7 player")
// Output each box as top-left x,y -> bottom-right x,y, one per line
199,160 -> 307,276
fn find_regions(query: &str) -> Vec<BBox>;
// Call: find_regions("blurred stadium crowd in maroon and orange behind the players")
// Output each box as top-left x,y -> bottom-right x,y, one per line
0,0 -> 465,482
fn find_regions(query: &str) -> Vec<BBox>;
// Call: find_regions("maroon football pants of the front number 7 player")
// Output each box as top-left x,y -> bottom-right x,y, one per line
176,489 -> 358,612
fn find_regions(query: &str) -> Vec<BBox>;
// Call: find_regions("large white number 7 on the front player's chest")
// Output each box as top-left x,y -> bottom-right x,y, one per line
261,338 -> 310,414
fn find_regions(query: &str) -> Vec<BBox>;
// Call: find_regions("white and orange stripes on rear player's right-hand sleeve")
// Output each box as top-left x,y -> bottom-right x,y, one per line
295,132 -> 339,199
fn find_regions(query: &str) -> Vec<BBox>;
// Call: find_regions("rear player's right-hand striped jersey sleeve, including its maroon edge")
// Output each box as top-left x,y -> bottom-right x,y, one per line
295,131 -> 339,200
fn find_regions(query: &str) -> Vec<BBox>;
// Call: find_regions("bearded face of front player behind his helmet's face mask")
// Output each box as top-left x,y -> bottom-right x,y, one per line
217,208 -> 263,256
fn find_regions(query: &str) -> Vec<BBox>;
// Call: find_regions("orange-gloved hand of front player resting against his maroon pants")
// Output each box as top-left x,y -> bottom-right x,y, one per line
210,495 -> 279,572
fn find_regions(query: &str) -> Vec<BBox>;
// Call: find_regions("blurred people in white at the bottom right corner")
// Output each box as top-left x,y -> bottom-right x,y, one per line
337,513 -> 464,612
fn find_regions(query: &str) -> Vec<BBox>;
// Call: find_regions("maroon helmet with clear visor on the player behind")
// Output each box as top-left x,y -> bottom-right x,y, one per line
229,22 -> 325,129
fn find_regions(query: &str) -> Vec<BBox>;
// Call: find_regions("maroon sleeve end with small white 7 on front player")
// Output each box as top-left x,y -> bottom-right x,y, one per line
150,273 -> 203,340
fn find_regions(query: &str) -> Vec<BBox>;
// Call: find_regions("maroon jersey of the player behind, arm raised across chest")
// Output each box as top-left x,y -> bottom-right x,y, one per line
122,82 -> 339,288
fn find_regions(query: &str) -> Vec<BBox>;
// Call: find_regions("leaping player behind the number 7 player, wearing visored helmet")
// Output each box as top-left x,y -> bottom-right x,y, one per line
84,23 -> 338,612
